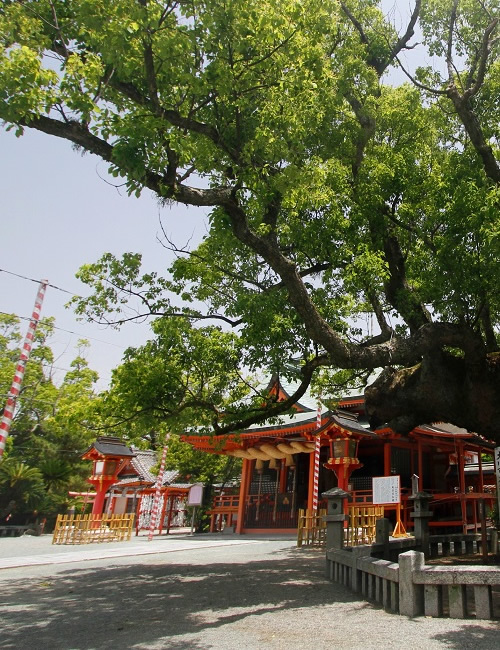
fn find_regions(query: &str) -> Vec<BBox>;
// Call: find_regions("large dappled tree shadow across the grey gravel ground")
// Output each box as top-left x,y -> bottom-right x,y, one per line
0,553 -> 354,650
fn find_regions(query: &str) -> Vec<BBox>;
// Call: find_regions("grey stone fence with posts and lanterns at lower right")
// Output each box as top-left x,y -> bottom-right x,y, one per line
323,488 -> 500,619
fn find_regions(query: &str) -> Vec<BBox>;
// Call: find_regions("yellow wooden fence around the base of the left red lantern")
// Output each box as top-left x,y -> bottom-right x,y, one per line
52,514 -> 135,544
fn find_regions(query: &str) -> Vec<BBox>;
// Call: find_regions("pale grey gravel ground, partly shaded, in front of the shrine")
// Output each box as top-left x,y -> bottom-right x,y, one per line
0,536 -> 500,650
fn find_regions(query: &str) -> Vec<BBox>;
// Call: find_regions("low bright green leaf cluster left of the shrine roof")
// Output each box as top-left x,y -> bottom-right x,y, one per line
96,319 -> 270,436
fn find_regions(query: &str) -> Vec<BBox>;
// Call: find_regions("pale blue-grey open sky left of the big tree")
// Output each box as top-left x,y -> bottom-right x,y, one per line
0,129 -> 205,389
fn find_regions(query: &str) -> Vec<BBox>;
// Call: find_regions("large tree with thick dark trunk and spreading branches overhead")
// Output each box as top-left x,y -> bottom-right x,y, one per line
0,0 -> 500,440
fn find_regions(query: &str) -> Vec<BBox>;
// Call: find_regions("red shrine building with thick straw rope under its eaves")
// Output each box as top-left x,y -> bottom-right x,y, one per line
183,380 -> 495,533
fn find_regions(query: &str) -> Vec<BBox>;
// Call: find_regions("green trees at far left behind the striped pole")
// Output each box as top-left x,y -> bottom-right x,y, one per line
0,315 -> 98,518
